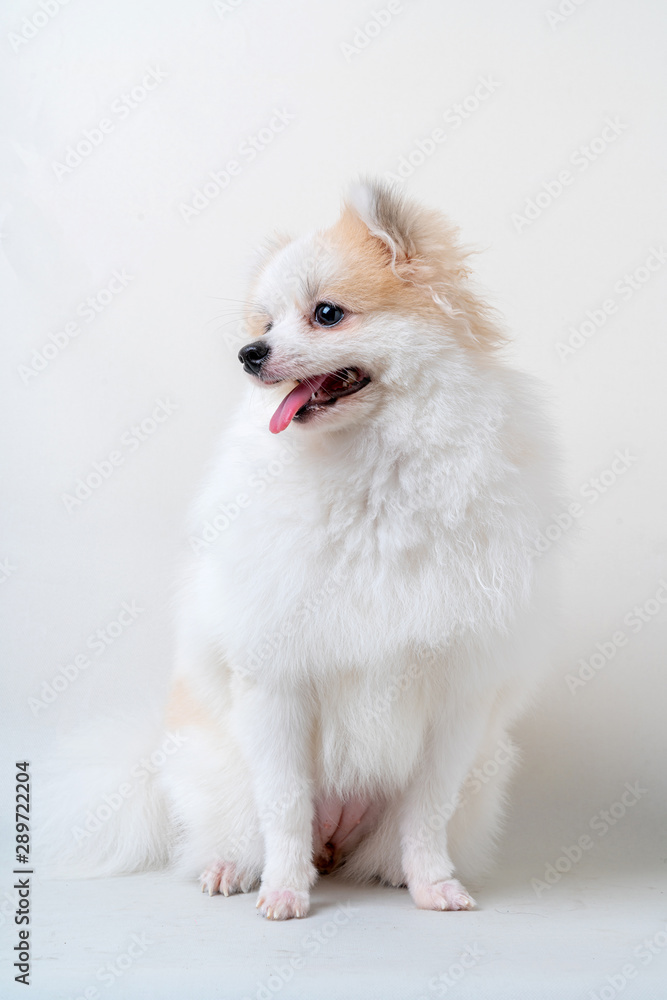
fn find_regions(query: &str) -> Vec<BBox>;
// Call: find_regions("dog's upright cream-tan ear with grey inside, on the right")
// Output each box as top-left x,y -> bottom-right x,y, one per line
346,180 -> 467,294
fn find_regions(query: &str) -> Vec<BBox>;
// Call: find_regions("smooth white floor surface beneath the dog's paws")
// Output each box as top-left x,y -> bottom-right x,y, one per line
11,866 -> 667,1000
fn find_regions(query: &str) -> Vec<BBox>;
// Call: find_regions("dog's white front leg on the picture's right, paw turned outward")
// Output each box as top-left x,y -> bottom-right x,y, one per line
401,702 -> 490,910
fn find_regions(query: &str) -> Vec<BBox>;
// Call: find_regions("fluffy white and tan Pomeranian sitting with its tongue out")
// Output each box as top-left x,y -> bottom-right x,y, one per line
44,183 -> 555,920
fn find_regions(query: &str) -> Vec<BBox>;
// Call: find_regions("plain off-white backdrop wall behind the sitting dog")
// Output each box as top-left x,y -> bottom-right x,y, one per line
0,0 -> 667,995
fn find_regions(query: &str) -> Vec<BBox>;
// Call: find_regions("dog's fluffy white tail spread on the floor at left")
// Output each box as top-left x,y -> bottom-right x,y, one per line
33,720 -> 173,878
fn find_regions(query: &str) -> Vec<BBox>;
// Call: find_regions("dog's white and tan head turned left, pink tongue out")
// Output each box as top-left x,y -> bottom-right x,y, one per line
239,183 -> 500,434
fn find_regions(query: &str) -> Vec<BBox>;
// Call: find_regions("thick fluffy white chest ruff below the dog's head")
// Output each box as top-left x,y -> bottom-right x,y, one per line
199,382 -> 533,696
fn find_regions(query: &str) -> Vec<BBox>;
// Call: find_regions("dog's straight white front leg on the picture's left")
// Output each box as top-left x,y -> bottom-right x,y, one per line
239,683 -> 316,920
